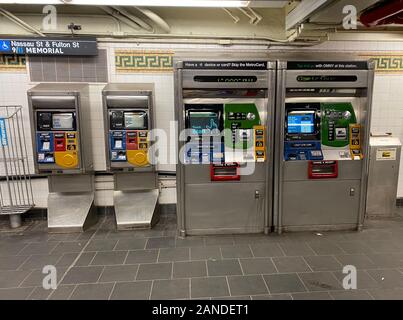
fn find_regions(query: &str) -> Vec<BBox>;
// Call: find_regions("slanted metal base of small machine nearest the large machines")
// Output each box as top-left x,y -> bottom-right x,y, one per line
113,189 -> 159,230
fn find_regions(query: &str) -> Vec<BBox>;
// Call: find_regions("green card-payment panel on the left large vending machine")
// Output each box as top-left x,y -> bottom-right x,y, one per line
224,103 -> 261,150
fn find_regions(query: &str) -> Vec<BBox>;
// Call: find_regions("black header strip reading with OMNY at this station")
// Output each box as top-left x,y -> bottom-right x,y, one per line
287,61 -> 368,70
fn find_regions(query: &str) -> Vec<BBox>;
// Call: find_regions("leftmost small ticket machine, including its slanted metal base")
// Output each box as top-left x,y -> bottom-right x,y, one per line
28,83 -> 96,232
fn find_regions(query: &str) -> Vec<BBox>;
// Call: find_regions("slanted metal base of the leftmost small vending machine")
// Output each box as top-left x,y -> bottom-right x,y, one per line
48,192 -> 97,233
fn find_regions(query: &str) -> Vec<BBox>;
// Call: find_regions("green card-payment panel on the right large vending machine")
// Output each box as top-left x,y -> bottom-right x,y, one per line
321,102 -> 357,147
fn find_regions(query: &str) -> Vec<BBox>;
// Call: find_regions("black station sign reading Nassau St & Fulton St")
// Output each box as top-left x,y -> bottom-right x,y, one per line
0,37 -> 98,56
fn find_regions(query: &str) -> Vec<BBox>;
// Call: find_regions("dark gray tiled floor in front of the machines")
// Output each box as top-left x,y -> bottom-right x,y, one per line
0,210 -> 403,299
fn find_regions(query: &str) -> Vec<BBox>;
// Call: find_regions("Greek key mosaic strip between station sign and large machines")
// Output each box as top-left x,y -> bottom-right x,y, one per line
115,50 -> 174,73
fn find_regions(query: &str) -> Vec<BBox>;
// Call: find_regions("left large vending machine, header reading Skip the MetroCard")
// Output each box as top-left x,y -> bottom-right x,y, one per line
175,60 -> 275,236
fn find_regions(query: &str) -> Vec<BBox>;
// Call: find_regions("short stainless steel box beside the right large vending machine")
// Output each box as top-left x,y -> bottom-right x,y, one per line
367,135 -> 402,217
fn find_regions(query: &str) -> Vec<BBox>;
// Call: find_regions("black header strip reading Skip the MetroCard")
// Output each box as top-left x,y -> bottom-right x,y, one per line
183,61 -> 267,70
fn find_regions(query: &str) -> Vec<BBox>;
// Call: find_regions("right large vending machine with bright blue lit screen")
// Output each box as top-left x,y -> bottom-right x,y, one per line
274,61 -> 374,232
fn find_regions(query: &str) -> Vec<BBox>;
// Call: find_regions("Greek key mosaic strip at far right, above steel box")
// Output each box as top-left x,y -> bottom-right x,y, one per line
359,53 -> 403,74
